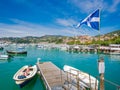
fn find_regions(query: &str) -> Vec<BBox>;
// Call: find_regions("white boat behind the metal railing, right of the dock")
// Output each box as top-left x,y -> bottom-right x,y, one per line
63,65 -> 99,90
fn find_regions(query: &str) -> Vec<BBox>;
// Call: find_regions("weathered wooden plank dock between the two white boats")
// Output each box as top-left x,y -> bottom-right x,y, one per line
37,62 -> 100,90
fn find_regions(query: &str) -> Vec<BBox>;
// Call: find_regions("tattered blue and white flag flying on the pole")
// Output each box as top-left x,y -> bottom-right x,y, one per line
77,9 -> 100,30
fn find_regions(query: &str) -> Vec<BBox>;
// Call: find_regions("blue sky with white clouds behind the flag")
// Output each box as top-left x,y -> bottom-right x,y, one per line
0,0 -> 120,37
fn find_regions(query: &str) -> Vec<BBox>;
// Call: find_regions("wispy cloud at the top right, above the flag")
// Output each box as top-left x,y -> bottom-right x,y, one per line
71,0 -> 120,13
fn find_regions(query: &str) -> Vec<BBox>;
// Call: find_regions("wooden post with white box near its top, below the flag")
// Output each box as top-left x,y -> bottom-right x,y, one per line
98,58 -> 105,90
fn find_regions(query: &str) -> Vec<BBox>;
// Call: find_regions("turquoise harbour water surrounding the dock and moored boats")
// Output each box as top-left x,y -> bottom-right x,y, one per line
0,47 -> 120,90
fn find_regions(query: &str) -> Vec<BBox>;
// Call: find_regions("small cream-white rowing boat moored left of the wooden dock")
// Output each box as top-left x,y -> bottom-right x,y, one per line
13,65 -> 37,87
